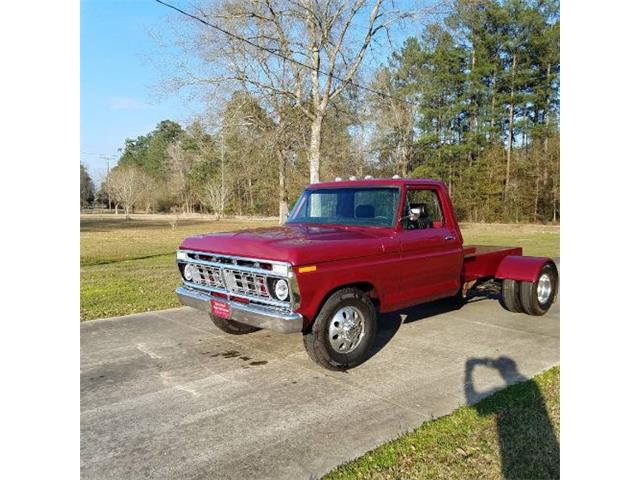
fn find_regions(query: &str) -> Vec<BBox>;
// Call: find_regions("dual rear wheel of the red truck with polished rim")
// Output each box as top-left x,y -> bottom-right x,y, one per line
501,263 -> 558,316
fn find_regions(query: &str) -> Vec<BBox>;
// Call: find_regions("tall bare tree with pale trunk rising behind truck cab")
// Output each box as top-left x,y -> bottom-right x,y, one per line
166,0 -> 434,183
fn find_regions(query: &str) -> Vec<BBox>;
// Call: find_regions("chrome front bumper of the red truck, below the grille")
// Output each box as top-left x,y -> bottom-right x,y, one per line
176,287 -> 302,333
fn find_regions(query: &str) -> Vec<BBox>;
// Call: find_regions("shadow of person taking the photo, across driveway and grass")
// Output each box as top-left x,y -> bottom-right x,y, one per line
464,357 -> 560,479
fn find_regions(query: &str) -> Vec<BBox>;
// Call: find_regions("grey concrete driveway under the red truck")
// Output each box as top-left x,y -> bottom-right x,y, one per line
80,288 -> 560,479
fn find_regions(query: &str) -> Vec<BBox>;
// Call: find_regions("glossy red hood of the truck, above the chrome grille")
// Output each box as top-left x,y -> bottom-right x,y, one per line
180,225 -> 390,265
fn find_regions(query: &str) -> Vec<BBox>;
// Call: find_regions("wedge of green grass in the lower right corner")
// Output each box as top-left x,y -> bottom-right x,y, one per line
325,367 -> 560,480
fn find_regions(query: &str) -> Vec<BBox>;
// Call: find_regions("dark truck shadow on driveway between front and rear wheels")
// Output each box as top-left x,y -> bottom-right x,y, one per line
369,282 -> 501,358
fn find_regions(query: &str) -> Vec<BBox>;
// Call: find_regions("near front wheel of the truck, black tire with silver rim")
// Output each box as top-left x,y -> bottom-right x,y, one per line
302,288 -> 378,370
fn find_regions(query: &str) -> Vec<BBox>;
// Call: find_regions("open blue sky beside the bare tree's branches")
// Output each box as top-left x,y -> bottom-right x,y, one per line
80,0 -> 430,179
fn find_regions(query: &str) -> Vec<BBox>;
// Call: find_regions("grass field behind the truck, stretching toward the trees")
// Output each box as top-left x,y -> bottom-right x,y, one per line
80,214 -> 560,320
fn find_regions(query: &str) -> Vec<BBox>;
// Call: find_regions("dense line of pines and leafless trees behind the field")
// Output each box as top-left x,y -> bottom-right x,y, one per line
92,0 -> 560,222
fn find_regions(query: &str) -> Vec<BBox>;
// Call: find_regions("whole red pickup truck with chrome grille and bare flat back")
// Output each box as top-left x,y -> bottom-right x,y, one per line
176,178 -> 558,369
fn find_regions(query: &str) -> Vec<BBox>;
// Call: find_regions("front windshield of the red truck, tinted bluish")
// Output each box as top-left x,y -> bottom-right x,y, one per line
287,187 -> 400,227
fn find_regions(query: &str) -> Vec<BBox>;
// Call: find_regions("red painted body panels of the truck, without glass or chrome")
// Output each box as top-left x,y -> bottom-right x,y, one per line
180,179 -> 551,323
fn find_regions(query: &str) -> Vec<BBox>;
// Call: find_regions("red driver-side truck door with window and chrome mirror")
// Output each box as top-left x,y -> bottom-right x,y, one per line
399,186 -> 463,305
